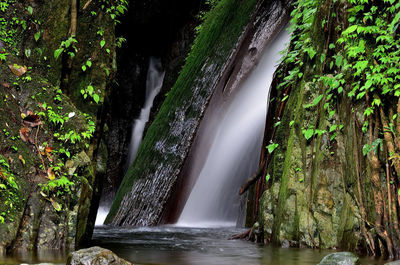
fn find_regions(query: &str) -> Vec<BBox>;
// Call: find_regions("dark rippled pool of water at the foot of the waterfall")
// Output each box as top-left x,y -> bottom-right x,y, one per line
92,226 -> 385,265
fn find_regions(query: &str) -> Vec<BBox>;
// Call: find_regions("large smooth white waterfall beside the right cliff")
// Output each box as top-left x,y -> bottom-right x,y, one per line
177,27 -> 289,227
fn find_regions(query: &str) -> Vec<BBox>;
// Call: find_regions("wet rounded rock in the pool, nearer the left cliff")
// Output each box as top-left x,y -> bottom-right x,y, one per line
67,247 -> 132,265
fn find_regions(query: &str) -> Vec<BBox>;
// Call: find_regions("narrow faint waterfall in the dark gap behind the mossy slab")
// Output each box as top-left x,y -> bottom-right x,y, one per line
95,57 -> 165,226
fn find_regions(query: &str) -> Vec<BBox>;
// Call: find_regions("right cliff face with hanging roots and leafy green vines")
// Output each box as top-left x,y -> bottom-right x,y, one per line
256,0 -> 399,257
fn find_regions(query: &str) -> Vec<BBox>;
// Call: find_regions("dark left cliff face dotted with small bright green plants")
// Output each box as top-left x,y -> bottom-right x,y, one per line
0,0 -> 115,254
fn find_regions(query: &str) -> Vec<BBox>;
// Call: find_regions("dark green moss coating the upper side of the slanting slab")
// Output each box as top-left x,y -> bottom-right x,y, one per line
106,0 -> 257,222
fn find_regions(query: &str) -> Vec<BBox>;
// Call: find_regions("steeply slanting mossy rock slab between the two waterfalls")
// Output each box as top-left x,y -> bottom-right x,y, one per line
106,0 -> 286,225
